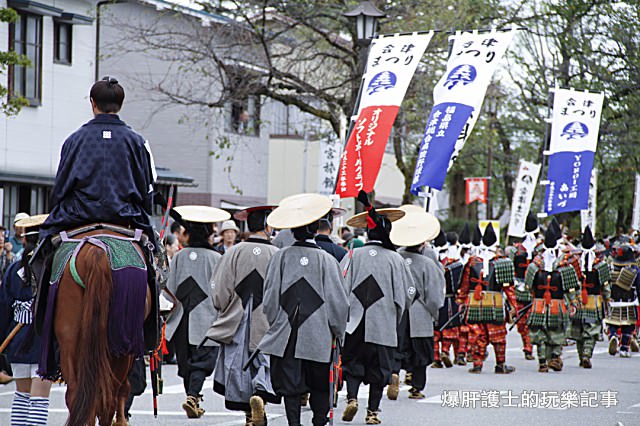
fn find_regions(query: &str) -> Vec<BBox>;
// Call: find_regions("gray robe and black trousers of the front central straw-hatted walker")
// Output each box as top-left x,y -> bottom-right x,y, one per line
259,241 -> 349,396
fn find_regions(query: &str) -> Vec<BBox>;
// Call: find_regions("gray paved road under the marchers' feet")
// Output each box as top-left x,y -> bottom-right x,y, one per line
0,331 -> 640,426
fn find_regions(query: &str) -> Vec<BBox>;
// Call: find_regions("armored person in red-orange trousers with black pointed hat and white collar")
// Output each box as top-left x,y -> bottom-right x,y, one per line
457,224 -> 516,374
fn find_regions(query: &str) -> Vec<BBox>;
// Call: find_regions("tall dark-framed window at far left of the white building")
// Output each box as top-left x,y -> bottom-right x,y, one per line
9,11 -> 42,106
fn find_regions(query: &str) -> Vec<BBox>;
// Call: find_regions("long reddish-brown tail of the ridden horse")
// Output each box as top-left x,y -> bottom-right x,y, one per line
67,244 -> 116,426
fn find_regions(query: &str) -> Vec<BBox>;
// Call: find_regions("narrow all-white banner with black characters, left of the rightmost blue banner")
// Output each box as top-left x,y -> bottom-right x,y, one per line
507,160 -> 540,237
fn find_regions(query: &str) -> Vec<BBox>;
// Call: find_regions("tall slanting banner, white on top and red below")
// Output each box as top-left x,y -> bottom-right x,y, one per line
336,32 -> 433,198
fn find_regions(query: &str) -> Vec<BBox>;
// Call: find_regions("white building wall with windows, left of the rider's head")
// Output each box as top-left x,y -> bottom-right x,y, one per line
0,0 -> 95,177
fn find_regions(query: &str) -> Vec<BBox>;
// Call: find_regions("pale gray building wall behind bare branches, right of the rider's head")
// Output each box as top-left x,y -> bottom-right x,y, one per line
100,2 -> 268,206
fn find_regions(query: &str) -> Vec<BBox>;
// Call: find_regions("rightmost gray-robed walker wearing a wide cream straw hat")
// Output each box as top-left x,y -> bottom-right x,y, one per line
390,206 -> 445,399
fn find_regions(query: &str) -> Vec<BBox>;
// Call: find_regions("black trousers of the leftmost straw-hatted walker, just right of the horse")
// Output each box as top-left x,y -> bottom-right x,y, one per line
171,315 -> 218,396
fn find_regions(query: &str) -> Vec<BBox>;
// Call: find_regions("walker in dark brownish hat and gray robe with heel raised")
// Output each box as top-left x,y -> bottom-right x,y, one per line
207,206 -> 280,426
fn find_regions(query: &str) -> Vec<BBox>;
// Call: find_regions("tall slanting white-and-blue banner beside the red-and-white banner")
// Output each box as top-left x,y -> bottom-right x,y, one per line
411,30 -> 513,195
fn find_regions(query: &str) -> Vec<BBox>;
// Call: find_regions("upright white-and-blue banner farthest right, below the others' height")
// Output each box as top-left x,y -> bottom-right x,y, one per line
545,89 -> 604,214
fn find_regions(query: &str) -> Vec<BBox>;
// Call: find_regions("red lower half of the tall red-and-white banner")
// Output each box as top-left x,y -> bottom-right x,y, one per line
336,105 -> 400,198
